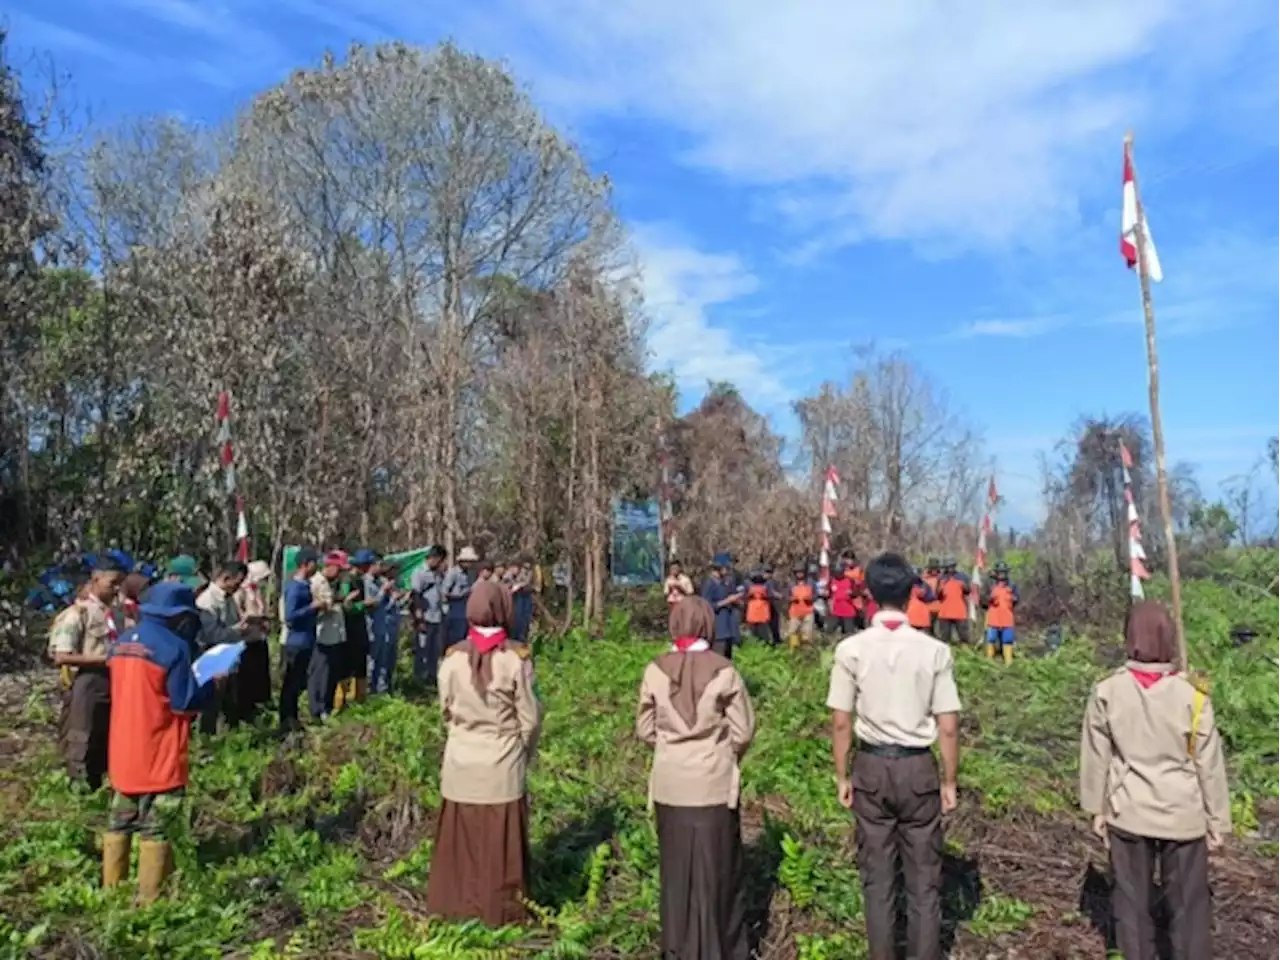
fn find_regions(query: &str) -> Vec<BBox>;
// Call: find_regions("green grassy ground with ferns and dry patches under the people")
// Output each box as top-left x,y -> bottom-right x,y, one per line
0,584 -> 1280,960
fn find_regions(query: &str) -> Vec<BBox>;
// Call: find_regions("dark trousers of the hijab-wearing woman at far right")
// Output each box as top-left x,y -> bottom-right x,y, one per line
1107,827 -> 1213,960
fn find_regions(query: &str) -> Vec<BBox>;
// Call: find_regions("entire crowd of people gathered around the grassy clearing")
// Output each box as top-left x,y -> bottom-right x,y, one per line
50,548 -> 1231,960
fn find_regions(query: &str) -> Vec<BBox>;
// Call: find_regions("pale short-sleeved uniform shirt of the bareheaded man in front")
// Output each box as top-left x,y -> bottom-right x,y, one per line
827,611 -> 960,748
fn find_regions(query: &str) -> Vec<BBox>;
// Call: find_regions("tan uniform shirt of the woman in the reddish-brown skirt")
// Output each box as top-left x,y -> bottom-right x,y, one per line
439,649 -> 541,804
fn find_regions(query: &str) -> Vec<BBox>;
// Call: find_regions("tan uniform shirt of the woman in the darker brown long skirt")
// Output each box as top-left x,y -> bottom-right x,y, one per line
636,654 -> 755,809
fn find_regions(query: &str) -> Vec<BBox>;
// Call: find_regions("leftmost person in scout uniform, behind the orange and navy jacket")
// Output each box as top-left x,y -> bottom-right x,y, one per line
49,558 -> 124,790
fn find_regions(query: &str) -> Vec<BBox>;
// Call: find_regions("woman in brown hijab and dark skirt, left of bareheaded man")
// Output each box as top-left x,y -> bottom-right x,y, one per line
636,596 -> 755,960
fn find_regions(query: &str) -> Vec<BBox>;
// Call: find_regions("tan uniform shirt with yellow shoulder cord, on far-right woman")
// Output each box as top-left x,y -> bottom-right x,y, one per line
1080,663 -> 1231,841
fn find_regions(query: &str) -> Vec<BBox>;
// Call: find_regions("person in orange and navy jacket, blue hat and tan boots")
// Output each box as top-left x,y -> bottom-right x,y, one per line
102,581 -> 227,904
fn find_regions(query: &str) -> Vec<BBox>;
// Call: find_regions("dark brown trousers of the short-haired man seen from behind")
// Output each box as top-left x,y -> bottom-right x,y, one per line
852,746 -> 942,960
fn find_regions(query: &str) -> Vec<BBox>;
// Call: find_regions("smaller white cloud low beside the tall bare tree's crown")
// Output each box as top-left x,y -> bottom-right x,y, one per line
635,227 -> 794,417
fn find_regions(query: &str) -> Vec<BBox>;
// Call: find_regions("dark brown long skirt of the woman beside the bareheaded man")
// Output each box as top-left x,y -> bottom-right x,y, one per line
655,804 -> 751,960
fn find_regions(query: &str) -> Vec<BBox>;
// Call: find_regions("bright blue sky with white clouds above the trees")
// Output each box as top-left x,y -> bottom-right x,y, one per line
4,0 -> 1280,529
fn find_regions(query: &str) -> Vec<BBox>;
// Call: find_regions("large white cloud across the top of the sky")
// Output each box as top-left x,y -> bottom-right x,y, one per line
458,0 -> 1267,260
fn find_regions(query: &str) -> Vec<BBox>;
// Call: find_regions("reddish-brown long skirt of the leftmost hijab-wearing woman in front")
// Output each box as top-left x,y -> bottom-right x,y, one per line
426,799 -> 529,927
